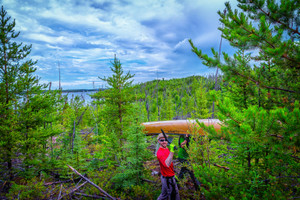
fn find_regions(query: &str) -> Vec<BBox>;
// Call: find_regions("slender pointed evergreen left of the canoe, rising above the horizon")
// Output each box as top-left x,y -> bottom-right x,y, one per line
93,56 -> 134,161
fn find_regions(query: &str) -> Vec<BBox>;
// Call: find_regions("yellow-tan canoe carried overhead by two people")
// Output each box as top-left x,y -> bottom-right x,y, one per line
142,119 -> 221,135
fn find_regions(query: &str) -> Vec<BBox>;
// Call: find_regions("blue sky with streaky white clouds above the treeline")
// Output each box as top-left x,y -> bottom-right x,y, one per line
1,0 -> 237,89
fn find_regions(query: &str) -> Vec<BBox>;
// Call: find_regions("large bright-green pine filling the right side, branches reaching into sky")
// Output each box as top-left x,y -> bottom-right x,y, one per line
190,0 -> 300,199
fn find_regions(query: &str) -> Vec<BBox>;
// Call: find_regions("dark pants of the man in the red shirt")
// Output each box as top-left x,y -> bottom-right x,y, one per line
157,176 -> 180,200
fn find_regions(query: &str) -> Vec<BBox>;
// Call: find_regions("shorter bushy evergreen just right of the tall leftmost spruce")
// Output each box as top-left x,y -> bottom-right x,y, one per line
16,88 -> 61,177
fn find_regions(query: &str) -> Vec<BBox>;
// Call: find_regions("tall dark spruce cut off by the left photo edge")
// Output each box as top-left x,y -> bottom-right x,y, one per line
0,6 -> 35,178
